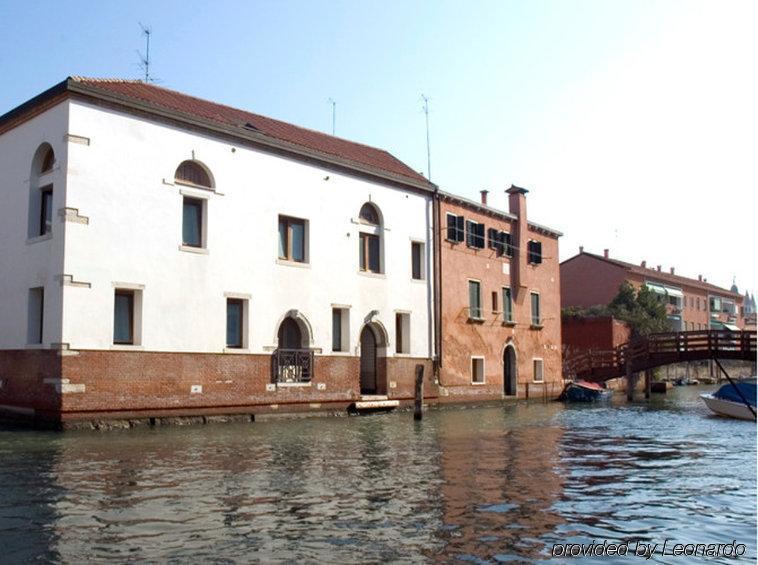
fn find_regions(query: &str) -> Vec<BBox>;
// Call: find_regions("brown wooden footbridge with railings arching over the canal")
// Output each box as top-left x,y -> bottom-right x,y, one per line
564,330 -> 756,382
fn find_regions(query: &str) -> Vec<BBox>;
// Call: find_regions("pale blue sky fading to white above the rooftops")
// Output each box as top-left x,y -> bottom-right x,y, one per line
0,0 -> 758,292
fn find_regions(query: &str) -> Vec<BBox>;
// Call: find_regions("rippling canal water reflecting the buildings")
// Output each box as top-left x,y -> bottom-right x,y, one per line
0,387 -> 756,563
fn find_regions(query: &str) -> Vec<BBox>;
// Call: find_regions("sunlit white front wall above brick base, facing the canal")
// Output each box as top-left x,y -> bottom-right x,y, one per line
63,102 -> 432,357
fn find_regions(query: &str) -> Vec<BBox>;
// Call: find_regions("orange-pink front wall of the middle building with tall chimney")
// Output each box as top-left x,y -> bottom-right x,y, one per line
438,189 -> 562,401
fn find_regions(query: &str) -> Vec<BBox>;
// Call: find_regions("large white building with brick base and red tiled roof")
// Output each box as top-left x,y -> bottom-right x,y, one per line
0,78 -> 435,424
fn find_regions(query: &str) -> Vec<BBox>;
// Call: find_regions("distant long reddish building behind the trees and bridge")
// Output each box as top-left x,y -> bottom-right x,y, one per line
561,248 -> 745,331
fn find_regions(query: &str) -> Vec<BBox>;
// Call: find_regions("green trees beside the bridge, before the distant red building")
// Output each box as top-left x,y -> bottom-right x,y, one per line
562,281 -> 671,336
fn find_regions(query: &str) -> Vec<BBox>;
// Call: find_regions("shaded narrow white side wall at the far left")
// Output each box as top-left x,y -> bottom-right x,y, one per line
0,102 -> 68,349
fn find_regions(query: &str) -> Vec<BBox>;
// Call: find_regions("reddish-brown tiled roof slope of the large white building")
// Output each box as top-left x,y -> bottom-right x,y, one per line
71,77 -> 428,183
